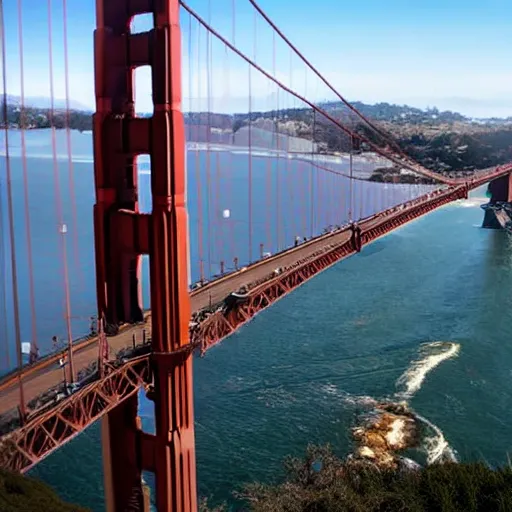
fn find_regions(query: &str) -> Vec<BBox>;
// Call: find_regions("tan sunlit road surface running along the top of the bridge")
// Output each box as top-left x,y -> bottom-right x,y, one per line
0,164 -> 512,422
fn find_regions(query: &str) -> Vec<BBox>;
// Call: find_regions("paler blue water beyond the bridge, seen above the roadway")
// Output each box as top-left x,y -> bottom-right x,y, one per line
0,130 -> 432,364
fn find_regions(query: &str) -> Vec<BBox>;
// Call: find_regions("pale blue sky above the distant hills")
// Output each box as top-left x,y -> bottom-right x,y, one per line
0,0 -> 512,117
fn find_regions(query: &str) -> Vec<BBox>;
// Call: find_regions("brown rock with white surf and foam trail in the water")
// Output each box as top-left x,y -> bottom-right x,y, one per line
344,341 -> 460,469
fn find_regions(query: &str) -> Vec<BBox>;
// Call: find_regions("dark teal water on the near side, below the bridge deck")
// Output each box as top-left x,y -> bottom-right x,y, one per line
4,134 -> 512,511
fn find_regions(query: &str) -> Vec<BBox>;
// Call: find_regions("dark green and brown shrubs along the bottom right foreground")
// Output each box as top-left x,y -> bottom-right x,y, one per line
237,446 -> 512,512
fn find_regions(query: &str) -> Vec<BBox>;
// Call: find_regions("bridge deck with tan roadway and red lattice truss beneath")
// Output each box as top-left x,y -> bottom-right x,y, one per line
0,180 -> 506,472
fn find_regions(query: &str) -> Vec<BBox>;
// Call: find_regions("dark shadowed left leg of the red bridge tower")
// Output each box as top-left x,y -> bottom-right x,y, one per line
93,0 -> 152,512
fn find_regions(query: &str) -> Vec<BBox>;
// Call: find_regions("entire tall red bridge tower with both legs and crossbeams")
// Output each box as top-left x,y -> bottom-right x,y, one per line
93,0 -> 197,512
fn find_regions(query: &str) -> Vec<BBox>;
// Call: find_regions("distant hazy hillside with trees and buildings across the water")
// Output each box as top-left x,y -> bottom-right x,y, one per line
4,98 -> 512,176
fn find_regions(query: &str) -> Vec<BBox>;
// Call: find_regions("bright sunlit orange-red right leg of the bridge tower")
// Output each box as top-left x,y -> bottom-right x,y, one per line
147,0 -> 197,512
